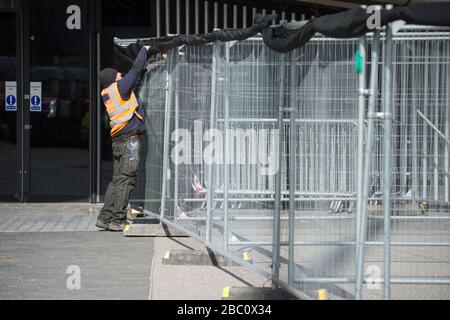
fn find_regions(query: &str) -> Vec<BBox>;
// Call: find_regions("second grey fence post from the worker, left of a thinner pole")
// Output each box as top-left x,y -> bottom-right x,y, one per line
205,43 -> 218,245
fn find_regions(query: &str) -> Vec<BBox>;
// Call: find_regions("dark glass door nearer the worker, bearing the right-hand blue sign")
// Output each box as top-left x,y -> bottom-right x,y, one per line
28,0 -> 90,202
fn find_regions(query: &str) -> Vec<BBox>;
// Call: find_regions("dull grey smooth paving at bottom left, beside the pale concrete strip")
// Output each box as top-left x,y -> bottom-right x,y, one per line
0,232 -> 153,300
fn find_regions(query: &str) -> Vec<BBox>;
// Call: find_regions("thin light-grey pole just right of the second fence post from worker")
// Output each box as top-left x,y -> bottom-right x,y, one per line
223,42 -> 231,252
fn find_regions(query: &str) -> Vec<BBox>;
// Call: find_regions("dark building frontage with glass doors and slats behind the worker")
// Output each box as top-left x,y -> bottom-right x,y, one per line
0,0 -> 326,202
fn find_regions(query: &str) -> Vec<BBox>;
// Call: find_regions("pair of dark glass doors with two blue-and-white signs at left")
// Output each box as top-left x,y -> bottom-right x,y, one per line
0,0 -> 96,202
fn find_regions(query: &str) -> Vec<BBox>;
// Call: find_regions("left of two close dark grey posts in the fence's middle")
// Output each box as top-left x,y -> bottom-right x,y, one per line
272,54 -> 286,287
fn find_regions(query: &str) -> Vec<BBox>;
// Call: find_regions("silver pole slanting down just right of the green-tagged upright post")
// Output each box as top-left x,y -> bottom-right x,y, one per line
356,30 -> 380,300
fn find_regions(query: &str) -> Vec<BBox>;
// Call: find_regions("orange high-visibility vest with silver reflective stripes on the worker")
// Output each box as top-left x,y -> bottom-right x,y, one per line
102,82 -> 143,137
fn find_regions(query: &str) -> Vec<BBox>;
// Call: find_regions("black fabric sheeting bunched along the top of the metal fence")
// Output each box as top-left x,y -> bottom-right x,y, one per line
114,2 -> 450,64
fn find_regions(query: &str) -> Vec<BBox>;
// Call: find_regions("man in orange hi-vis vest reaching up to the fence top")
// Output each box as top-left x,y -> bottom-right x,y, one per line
96,46 -> 150,231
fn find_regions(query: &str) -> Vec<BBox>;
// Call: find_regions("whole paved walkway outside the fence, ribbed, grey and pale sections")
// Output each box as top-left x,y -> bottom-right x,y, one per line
0,204 -> 268,300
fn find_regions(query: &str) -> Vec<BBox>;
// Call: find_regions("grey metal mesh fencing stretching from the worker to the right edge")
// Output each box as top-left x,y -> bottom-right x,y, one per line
119,27 -> 450,299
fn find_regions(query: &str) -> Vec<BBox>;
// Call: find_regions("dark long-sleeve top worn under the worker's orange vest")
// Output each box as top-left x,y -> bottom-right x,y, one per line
108,48 -> 148,140
